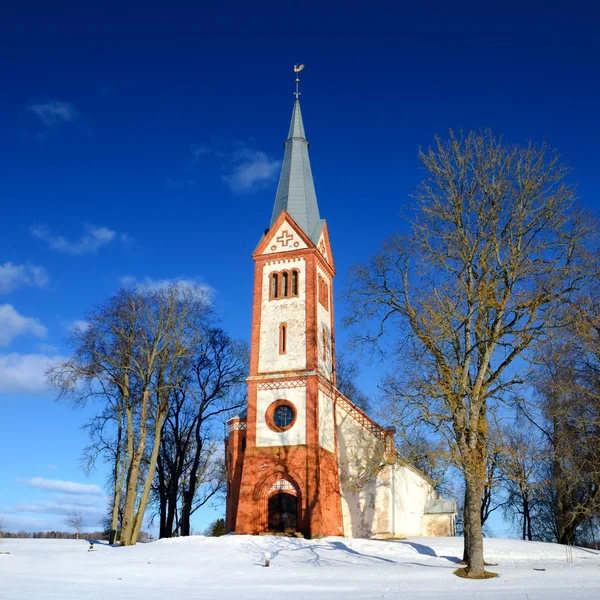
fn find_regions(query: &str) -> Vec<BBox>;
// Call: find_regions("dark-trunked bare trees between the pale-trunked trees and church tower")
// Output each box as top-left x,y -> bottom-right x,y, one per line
153,328 -> 248,538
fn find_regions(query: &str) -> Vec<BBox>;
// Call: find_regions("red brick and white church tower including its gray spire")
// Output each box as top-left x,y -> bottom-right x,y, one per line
226,96 -> 344,537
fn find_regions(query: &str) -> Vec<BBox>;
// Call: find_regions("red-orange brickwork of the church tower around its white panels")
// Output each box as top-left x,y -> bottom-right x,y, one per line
225,211 -> 344,537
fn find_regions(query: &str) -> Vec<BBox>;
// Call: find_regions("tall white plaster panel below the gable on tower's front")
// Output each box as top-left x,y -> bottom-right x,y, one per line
258,258 -> 306,373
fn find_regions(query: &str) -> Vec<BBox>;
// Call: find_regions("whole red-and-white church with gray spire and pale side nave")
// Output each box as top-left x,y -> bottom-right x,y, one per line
225,85 -> 456,538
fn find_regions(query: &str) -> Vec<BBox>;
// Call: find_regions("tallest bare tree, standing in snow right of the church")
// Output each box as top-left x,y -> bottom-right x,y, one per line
348,130 -> 594,578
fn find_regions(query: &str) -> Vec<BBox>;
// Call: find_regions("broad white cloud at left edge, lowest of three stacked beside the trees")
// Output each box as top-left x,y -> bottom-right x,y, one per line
0,352 -> 62,394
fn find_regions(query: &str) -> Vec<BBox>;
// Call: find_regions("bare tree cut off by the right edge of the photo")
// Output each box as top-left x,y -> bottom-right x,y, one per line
527,308 -> 600,544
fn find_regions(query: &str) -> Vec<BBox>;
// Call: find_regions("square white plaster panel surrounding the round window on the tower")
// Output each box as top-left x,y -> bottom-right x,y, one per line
256,387 -> 306,446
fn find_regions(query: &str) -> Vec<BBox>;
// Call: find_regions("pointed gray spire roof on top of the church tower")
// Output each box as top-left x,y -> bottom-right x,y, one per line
271,100 -> 324,244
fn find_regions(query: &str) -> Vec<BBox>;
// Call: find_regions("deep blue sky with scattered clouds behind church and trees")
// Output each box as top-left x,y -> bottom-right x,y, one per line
0,1 -> 600,529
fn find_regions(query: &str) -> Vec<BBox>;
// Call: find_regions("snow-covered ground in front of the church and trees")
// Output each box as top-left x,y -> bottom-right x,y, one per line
0,536 -> 600,600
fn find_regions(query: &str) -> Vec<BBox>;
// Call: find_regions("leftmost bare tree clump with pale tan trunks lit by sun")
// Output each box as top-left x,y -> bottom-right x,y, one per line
48,285 -> 213,545
